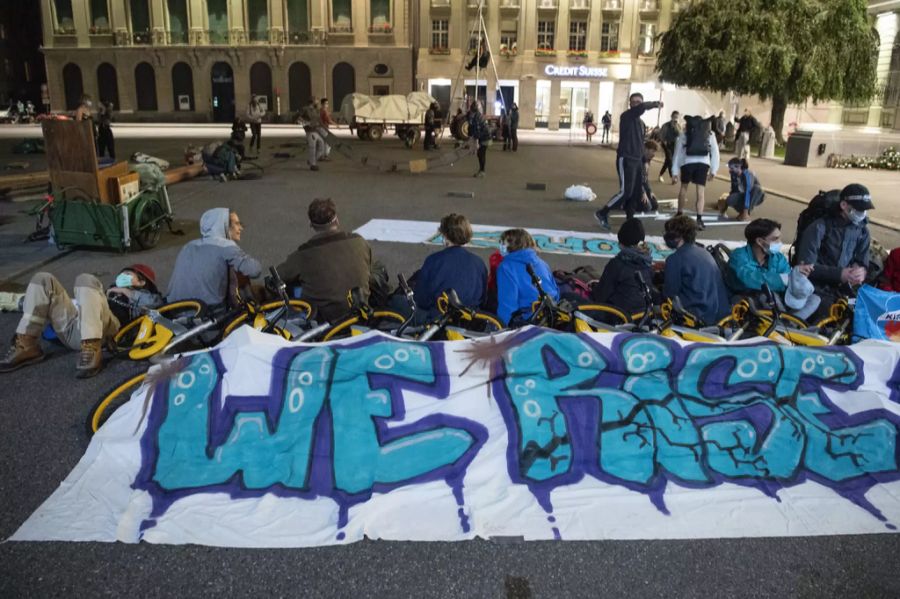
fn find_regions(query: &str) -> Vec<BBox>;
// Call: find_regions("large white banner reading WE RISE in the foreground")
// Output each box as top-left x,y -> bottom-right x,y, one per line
13,327 -> 900,547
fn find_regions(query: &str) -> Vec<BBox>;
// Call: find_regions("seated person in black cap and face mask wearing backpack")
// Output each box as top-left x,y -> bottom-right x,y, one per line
796,183 -> 875,309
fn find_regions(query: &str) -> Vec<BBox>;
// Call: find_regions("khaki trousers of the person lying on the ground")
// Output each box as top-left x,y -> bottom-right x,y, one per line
16,272 -> 119,349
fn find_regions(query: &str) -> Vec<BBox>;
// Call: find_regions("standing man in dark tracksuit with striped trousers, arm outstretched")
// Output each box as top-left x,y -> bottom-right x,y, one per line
594,93 -> 663,231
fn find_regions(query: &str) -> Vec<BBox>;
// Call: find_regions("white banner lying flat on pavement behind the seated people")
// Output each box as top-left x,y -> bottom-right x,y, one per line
355,218 -> 745,260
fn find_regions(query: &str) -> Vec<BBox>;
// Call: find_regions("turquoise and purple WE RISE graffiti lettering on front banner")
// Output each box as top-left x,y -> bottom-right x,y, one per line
135,329 -> 898,530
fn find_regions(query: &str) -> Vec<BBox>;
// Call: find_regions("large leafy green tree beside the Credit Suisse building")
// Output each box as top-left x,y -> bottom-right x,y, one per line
656,0 -> 878,142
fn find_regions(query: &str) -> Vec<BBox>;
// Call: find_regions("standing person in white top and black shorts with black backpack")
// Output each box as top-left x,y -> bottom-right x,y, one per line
672,116 -> 719,231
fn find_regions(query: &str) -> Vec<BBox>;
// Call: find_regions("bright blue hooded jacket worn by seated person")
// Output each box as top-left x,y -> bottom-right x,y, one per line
497,248 -> 559,324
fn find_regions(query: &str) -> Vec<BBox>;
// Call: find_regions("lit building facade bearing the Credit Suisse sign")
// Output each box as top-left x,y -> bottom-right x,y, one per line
416,0 -> 704,129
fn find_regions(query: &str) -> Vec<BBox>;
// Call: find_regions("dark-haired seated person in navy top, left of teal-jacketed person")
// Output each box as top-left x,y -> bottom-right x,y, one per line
663,214 -> 731,324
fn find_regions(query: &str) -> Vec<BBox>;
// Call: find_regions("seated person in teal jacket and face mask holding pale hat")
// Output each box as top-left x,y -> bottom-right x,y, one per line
725,218 -> 818,318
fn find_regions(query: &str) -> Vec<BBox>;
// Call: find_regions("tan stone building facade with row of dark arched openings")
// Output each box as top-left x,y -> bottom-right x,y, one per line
41,0 -> 413,122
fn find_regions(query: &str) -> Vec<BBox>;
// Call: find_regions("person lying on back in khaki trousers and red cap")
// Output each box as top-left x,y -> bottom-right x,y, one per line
0,264 -> 162,378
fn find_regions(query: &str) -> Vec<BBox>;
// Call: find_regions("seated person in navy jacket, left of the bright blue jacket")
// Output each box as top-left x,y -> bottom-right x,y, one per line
414,213 -> 487,320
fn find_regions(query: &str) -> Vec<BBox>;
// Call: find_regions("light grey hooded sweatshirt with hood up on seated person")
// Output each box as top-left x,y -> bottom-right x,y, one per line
166,208 -> 262,307
